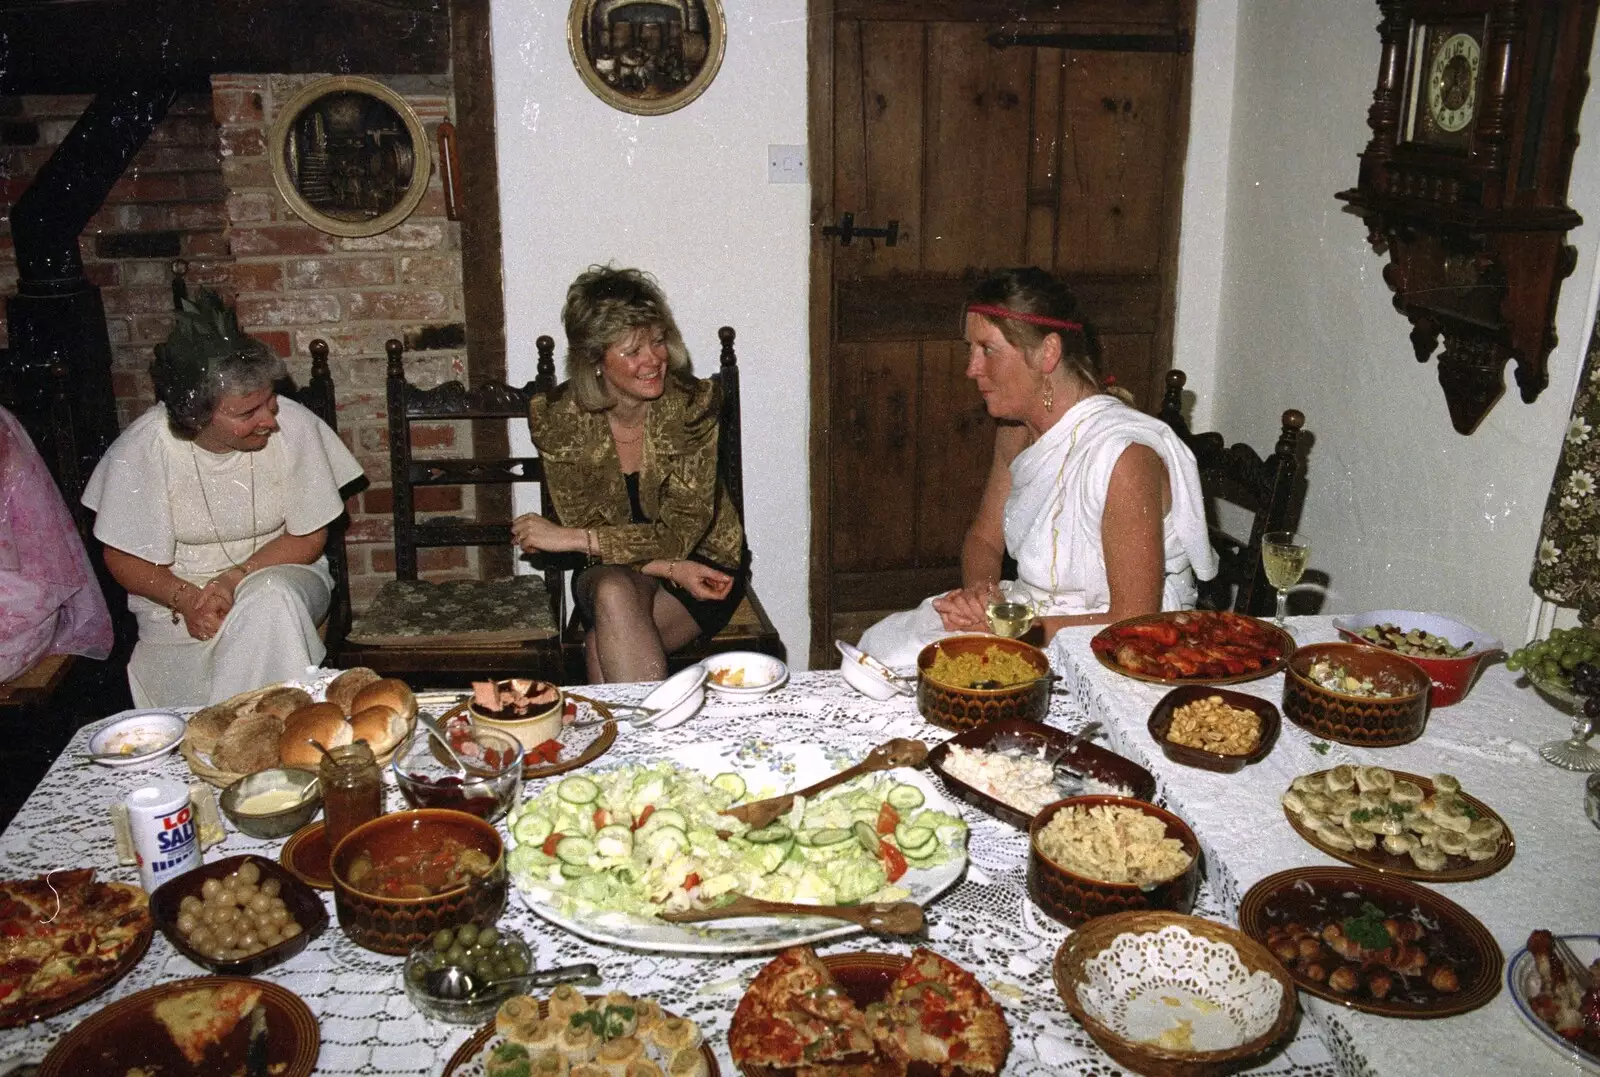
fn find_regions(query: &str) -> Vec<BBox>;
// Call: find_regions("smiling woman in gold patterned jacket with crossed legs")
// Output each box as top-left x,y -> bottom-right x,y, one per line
512,266 -> 749,682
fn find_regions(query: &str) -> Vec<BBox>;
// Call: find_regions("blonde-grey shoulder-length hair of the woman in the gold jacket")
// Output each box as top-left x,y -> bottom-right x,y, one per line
562,266 -> 690,411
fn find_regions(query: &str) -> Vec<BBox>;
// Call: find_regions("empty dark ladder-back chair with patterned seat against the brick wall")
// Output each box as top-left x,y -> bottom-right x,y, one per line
339,336 -> 566,687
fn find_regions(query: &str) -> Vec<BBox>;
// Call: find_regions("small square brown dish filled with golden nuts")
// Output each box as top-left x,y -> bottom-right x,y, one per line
1149,685 -> 1283,775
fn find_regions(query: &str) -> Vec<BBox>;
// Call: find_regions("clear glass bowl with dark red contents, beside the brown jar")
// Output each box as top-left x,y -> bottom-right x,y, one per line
389,725 -> 522,823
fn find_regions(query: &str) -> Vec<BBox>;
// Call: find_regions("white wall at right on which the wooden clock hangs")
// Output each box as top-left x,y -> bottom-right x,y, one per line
1179,0 -> 1600,643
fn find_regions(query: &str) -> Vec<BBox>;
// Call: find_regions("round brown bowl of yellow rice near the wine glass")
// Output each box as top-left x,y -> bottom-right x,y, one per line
917,634 -> 1054,731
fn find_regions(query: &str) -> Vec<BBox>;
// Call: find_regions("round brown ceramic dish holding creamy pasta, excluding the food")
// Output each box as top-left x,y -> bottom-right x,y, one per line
1027,797 -> 1200,928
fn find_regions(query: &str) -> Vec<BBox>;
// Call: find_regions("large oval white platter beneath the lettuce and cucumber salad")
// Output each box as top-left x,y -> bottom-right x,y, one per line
507,741 -> 966,954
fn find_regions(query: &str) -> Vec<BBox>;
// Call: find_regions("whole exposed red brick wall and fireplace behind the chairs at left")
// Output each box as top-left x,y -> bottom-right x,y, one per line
0,75 -> 489,610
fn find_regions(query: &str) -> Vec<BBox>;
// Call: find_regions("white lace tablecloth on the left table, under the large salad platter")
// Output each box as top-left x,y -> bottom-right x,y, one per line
0,672 -> 1350,1077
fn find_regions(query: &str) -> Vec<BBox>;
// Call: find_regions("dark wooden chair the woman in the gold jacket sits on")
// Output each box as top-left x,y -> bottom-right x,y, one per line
563,325 -> 787,680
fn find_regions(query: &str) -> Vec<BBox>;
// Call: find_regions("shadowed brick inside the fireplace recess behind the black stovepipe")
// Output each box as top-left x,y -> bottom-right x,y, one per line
0,94 -> 230,426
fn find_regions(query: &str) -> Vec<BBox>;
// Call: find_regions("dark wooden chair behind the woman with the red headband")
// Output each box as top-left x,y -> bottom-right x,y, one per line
1157,370 -> 1306,616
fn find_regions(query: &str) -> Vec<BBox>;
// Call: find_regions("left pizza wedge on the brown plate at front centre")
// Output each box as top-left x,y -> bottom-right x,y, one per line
728,946 -> 875,1072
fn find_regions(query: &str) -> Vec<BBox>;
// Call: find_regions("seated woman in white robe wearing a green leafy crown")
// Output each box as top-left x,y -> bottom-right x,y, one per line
83,291 -> 362,707
